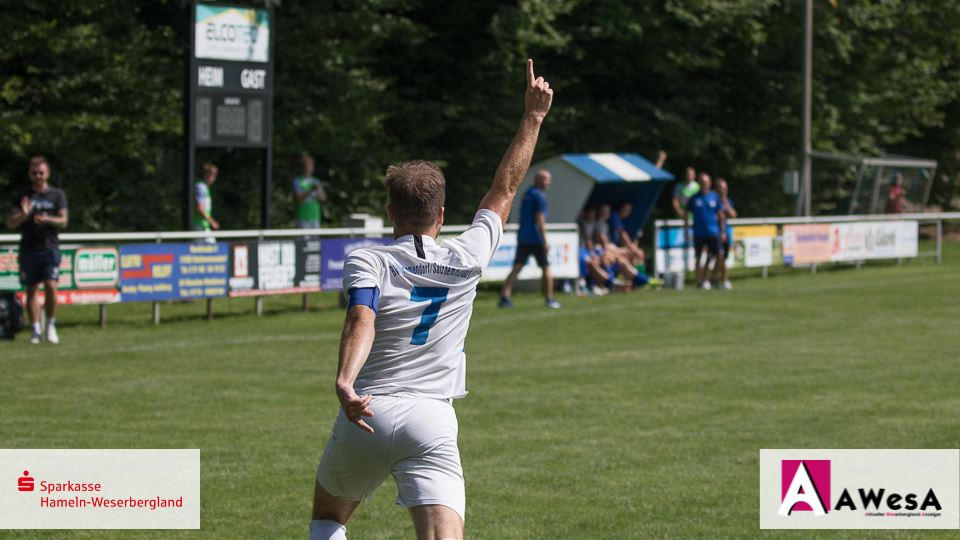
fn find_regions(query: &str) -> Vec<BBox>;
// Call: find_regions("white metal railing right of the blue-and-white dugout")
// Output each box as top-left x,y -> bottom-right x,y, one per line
653,212 -> 960,277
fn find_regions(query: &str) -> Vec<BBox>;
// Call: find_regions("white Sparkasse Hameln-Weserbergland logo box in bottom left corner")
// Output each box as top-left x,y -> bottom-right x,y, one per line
0,449 -> 200,529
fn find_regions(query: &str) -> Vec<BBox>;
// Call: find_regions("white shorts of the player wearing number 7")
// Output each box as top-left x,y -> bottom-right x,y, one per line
317,396 -> 466,519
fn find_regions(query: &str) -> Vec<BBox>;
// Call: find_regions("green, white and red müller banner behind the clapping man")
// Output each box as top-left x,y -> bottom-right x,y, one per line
0,247 -> 120,304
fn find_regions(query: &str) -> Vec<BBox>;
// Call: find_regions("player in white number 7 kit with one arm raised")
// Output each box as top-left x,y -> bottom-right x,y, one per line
310,60 -> 553,540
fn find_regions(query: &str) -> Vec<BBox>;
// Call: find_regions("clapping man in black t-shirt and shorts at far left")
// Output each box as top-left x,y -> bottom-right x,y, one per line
6,156 -> 68,344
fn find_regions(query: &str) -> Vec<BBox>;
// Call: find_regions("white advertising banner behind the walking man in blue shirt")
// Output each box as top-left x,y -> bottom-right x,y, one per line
480,232 -> 580,281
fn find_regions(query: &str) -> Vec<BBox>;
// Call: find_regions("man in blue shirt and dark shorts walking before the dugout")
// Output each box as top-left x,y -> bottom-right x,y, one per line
498,169 -> 560,309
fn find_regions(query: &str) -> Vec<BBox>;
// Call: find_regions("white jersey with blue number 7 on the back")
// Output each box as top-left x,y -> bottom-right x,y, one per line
343,210 -> 503,399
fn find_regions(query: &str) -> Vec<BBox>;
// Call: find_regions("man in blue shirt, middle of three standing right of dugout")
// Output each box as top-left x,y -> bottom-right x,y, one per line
687,173 -> 727,289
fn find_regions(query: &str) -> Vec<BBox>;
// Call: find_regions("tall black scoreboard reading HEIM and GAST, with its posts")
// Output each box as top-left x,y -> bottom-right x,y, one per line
183,2 -> 274,229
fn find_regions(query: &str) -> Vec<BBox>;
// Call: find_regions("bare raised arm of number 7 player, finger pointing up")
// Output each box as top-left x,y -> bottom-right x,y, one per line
480,60 -> 553,223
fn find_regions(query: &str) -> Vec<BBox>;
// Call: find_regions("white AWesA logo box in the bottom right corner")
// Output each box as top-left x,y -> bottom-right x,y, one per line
760,449 -> 960,529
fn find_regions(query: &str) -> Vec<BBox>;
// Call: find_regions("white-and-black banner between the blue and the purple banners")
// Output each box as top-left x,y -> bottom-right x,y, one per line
229,239 -> 321,296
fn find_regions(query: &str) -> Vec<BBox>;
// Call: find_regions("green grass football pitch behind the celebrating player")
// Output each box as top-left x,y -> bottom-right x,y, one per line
0,249 -> 960,539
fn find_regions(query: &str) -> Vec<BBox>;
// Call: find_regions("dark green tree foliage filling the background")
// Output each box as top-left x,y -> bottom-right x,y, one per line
0,0 -> 960,230
